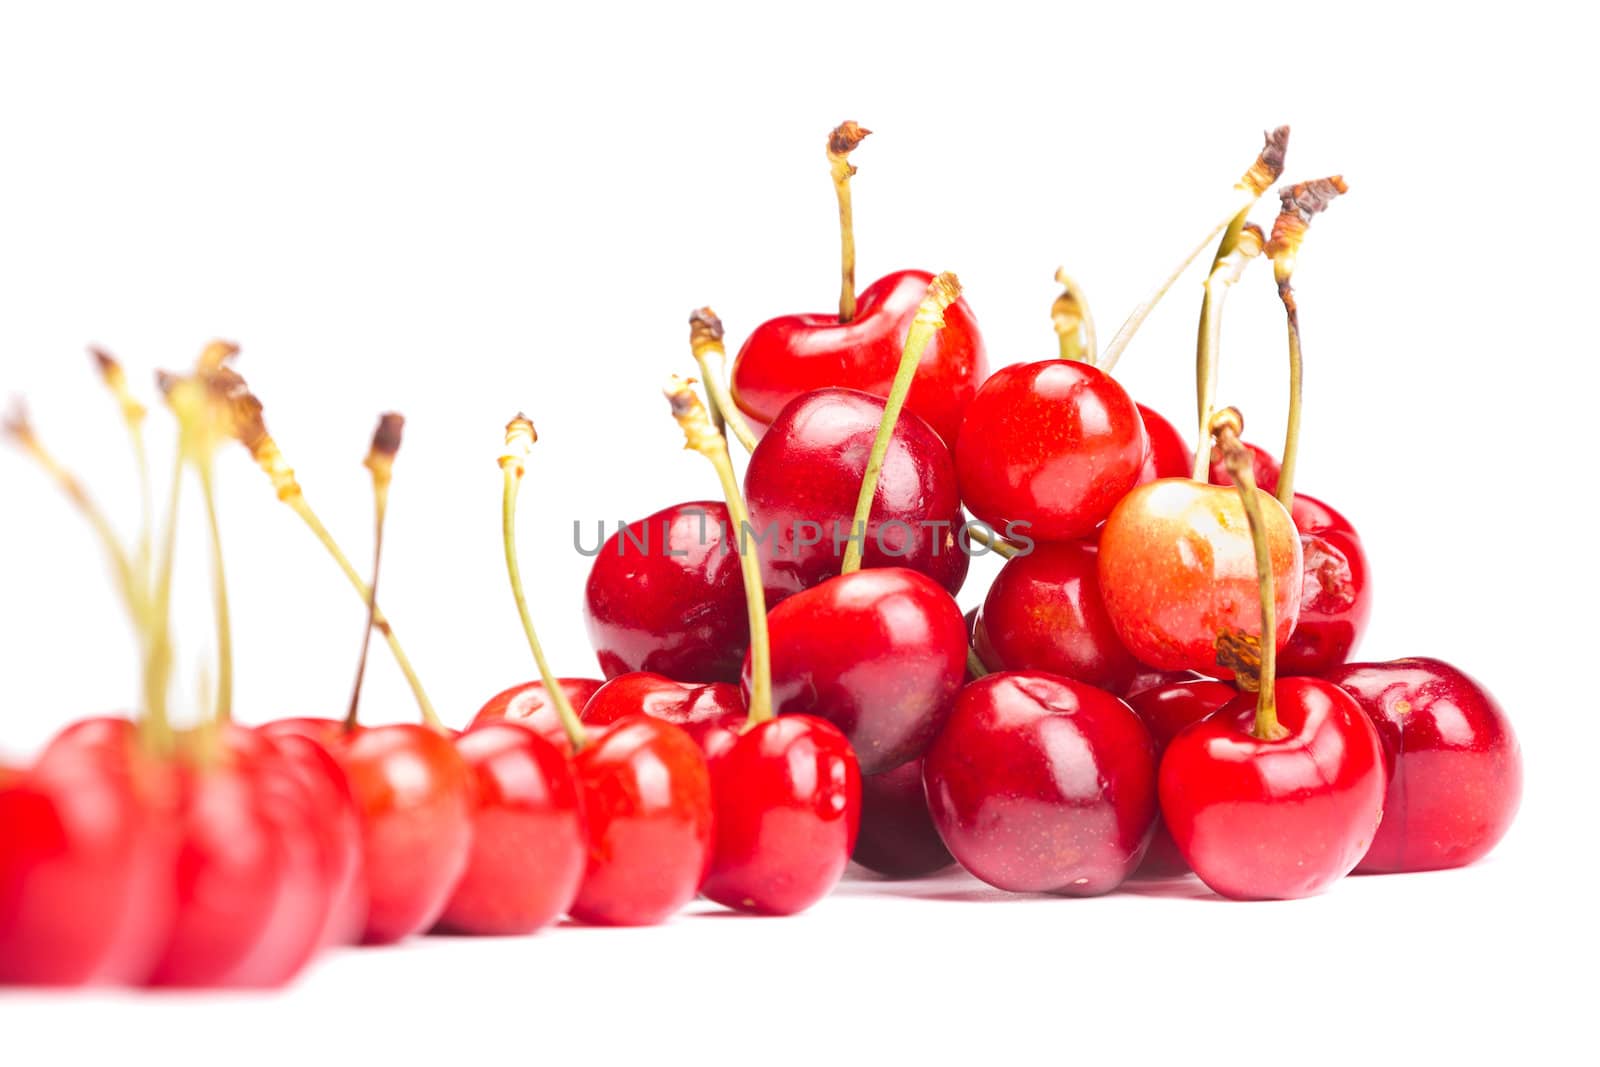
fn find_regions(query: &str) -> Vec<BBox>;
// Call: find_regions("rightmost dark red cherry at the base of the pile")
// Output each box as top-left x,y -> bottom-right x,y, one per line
1326,657 -> 1522,872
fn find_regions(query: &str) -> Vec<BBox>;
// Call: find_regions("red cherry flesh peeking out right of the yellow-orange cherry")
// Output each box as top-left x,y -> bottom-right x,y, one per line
1278,493 -> 1373,675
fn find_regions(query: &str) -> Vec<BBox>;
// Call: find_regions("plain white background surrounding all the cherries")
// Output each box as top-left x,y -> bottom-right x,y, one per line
0,2 -> 1600,1064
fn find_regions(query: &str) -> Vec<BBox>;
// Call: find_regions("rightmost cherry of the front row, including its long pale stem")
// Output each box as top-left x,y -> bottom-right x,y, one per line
665,379 -> 882,915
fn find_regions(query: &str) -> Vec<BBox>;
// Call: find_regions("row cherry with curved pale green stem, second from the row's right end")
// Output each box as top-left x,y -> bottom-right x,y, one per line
499,414 -> 720,926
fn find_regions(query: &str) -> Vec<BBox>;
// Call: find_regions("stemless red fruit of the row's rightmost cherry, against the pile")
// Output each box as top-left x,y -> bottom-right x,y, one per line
701,715 -> 861,915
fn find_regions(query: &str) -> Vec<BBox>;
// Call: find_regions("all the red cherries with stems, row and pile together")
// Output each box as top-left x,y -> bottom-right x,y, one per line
0,123 -> 1522,987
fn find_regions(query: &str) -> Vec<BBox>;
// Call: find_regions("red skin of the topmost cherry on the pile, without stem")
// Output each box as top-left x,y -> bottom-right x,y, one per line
733,270 -> 989,442
